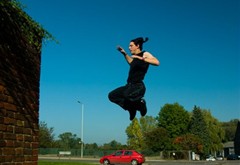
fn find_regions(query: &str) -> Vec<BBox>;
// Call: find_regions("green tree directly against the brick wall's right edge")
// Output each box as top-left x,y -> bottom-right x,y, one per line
39,121 -> 54,148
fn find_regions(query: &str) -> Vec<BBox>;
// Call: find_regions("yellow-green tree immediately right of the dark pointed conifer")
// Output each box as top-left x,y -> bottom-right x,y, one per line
202,110 -> 225,154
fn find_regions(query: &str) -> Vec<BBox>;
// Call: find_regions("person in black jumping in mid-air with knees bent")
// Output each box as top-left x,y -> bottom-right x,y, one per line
108,37 -> 160,120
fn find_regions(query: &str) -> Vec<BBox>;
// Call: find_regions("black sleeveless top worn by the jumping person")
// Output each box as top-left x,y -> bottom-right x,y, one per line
127,51 -> 149,84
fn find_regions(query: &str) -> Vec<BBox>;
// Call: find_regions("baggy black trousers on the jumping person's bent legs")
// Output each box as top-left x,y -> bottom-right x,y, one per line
108,83 -> 146,110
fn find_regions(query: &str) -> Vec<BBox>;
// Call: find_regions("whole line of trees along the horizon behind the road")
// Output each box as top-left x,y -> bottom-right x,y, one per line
39,103 -> 239,156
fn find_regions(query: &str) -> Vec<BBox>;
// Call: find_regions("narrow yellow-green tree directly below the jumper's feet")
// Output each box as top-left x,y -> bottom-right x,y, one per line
126,118 -> 143,151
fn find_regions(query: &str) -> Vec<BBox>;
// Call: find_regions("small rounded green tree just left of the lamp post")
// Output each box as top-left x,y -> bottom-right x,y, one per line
58,132 -> 82,150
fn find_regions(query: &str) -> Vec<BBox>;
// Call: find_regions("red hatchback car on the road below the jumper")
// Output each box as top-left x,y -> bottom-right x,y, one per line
100,150 -> 145,165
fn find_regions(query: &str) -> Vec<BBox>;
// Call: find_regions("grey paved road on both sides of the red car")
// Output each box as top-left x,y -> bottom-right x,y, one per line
38,156 -> 240,165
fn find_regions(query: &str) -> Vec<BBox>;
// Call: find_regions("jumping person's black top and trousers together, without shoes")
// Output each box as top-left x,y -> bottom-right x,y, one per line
108,52 -> 149,111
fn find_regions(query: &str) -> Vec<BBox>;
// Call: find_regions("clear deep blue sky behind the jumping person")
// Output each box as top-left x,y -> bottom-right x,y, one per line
20,0 -> 240,144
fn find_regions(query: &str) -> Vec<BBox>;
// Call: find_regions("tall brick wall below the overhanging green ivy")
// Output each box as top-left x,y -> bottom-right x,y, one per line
0,0 -> 41,165
